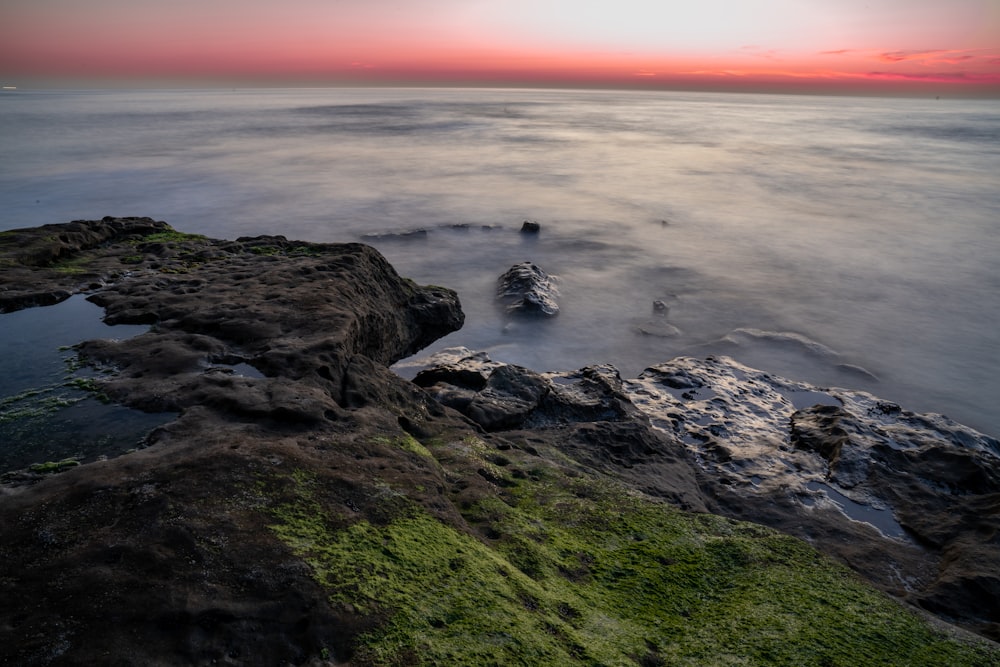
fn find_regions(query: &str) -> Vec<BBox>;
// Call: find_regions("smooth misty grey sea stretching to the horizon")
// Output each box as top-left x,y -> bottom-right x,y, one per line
0,89 -> 1000,435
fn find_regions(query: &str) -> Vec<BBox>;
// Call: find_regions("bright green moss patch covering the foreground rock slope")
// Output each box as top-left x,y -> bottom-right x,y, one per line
271,460 -> 1000,666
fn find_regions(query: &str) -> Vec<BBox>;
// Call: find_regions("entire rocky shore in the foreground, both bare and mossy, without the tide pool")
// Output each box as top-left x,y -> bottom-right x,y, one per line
0,218 -> 1000,665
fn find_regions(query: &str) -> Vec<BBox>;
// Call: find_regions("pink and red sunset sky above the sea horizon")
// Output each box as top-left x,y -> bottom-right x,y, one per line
0,0 -> 1000,97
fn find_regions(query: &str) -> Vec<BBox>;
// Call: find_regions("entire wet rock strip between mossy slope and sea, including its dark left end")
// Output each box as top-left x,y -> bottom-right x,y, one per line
414,349 -> 1000,637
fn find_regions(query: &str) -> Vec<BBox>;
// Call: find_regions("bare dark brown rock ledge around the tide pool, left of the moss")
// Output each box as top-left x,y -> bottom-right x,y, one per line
0,219 -> 467,665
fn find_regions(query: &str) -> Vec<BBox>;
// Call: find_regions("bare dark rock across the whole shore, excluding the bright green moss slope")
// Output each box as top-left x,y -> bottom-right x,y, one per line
0,219 -> 1000,665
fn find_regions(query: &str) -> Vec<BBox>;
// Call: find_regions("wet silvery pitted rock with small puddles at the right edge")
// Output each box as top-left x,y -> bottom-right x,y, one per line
624,358 -> 1000,638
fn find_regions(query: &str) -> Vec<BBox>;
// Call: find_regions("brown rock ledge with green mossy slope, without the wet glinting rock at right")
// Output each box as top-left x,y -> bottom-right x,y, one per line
0,218 -> 1000,667
